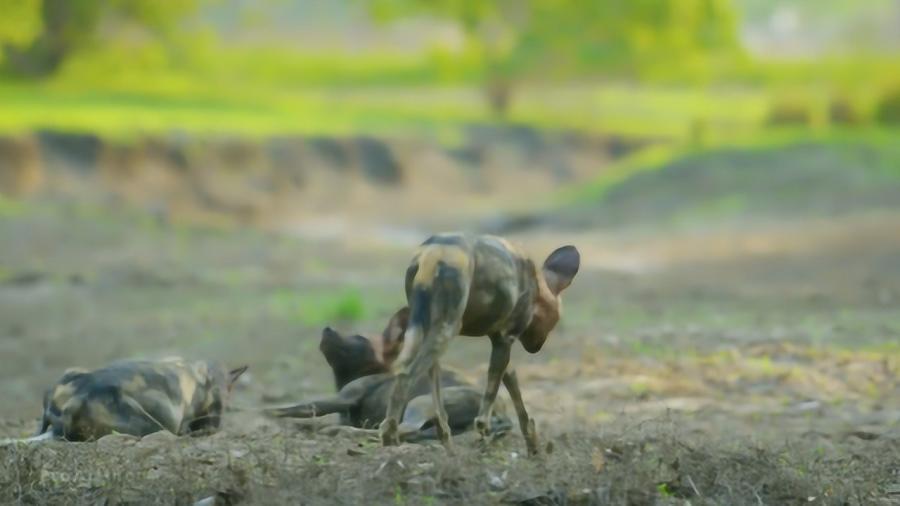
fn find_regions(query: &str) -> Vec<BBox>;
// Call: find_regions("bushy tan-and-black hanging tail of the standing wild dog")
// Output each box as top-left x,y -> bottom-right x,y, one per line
394,242 -> 474,381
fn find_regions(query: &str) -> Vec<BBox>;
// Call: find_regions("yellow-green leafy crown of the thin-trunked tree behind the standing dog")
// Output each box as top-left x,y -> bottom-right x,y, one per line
368,0 -> 737,113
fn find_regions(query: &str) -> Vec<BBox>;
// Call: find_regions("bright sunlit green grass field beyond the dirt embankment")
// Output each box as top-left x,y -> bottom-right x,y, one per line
0,49 -> 896,143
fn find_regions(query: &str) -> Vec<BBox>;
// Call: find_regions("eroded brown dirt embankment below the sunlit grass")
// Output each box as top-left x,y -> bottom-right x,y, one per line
0,126 -> 638,228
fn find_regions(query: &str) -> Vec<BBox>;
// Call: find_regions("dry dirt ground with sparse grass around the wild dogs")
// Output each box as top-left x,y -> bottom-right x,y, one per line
0,199 -> 900,505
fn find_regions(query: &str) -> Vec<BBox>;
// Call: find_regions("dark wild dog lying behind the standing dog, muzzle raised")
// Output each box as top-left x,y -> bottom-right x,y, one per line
266,307 -> 511,441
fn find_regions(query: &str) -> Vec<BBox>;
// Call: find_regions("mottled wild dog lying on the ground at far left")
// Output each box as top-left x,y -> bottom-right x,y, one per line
9,358 -> 247,441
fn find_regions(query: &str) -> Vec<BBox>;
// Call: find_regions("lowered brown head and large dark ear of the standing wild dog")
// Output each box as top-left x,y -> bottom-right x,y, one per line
519,246 -> 581,353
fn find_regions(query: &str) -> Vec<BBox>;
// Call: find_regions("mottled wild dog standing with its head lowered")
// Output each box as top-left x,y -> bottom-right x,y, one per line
380,234 -> 580,454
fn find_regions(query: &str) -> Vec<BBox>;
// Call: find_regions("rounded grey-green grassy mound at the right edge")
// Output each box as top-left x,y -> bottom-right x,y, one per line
537,128 -> 900,231
